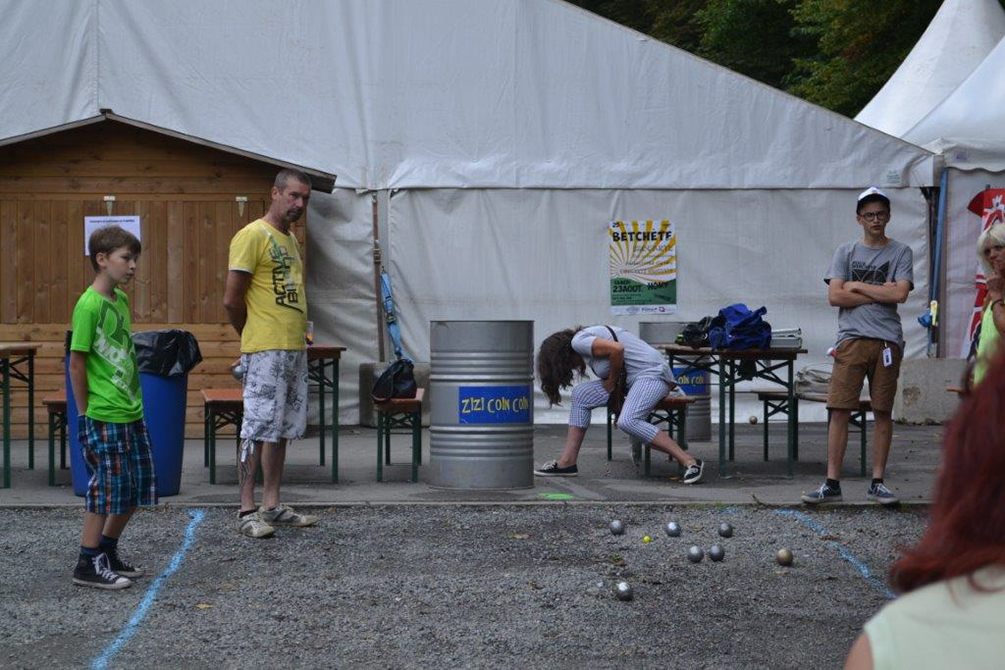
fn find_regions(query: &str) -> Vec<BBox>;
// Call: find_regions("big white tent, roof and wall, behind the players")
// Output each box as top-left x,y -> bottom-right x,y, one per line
0,0 -> 936,421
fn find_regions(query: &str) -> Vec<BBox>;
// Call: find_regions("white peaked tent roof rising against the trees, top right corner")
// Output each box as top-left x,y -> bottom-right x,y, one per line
855,0 -> 1005,138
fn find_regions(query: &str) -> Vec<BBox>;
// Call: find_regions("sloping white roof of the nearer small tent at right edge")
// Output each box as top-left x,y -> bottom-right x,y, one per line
903,31 -> 1005,172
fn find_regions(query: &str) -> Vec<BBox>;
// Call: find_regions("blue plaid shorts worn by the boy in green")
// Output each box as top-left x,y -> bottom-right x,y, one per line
77,417 -> 157,514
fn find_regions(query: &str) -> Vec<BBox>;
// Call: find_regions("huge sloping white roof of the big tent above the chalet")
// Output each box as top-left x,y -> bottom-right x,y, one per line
0,0 -> 935,189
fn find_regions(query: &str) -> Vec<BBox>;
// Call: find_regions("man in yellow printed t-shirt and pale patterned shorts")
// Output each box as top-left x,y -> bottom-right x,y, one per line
223,170 -> 318,537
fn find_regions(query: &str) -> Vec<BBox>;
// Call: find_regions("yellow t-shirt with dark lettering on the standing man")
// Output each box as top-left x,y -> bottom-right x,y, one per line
229,219 -> 308,354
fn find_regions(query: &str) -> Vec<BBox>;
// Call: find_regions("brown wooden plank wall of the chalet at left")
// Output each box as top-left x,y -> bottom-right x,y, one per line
0,121 -> 307,438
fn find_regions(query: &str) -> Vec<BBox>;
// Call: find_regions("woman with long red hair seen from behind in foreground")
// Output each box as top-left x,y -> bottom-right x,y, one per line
845,355 -> 1005,670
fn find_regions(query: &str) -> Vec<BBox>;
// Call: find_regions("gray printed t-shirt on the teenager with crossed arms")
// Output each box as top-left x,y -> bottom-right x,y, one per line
823,240 -> 915,348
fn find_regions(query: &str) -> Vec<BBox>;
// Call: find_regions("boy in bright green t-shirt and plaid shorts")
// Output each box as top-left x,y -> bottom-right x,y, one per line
69,226 -> 157,589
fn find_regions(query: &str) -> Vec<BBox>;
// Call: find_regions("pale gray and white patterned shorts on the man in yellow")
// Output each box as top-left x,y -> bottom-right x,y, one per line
241,350 -> 308,442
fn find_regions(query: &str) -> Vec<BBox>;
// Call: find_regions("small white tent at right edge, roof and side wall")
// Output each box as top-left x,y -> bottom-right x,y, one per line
905,32 -> 1005,356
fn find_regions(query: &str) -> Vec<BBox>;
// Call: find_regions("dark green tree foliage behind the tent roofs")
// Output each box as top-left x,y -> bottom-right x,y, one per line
574,0 -> 1005,116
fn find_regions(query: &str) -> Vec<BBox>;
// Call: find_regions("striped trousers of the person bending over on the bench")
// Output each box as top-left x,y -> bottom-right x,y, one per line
569,377 -> 670,444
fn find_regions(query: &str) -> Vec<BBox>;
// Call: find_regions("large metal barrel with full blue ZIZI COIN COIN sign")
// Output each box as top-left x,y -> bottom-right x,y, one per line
429,321 -> 534,489
